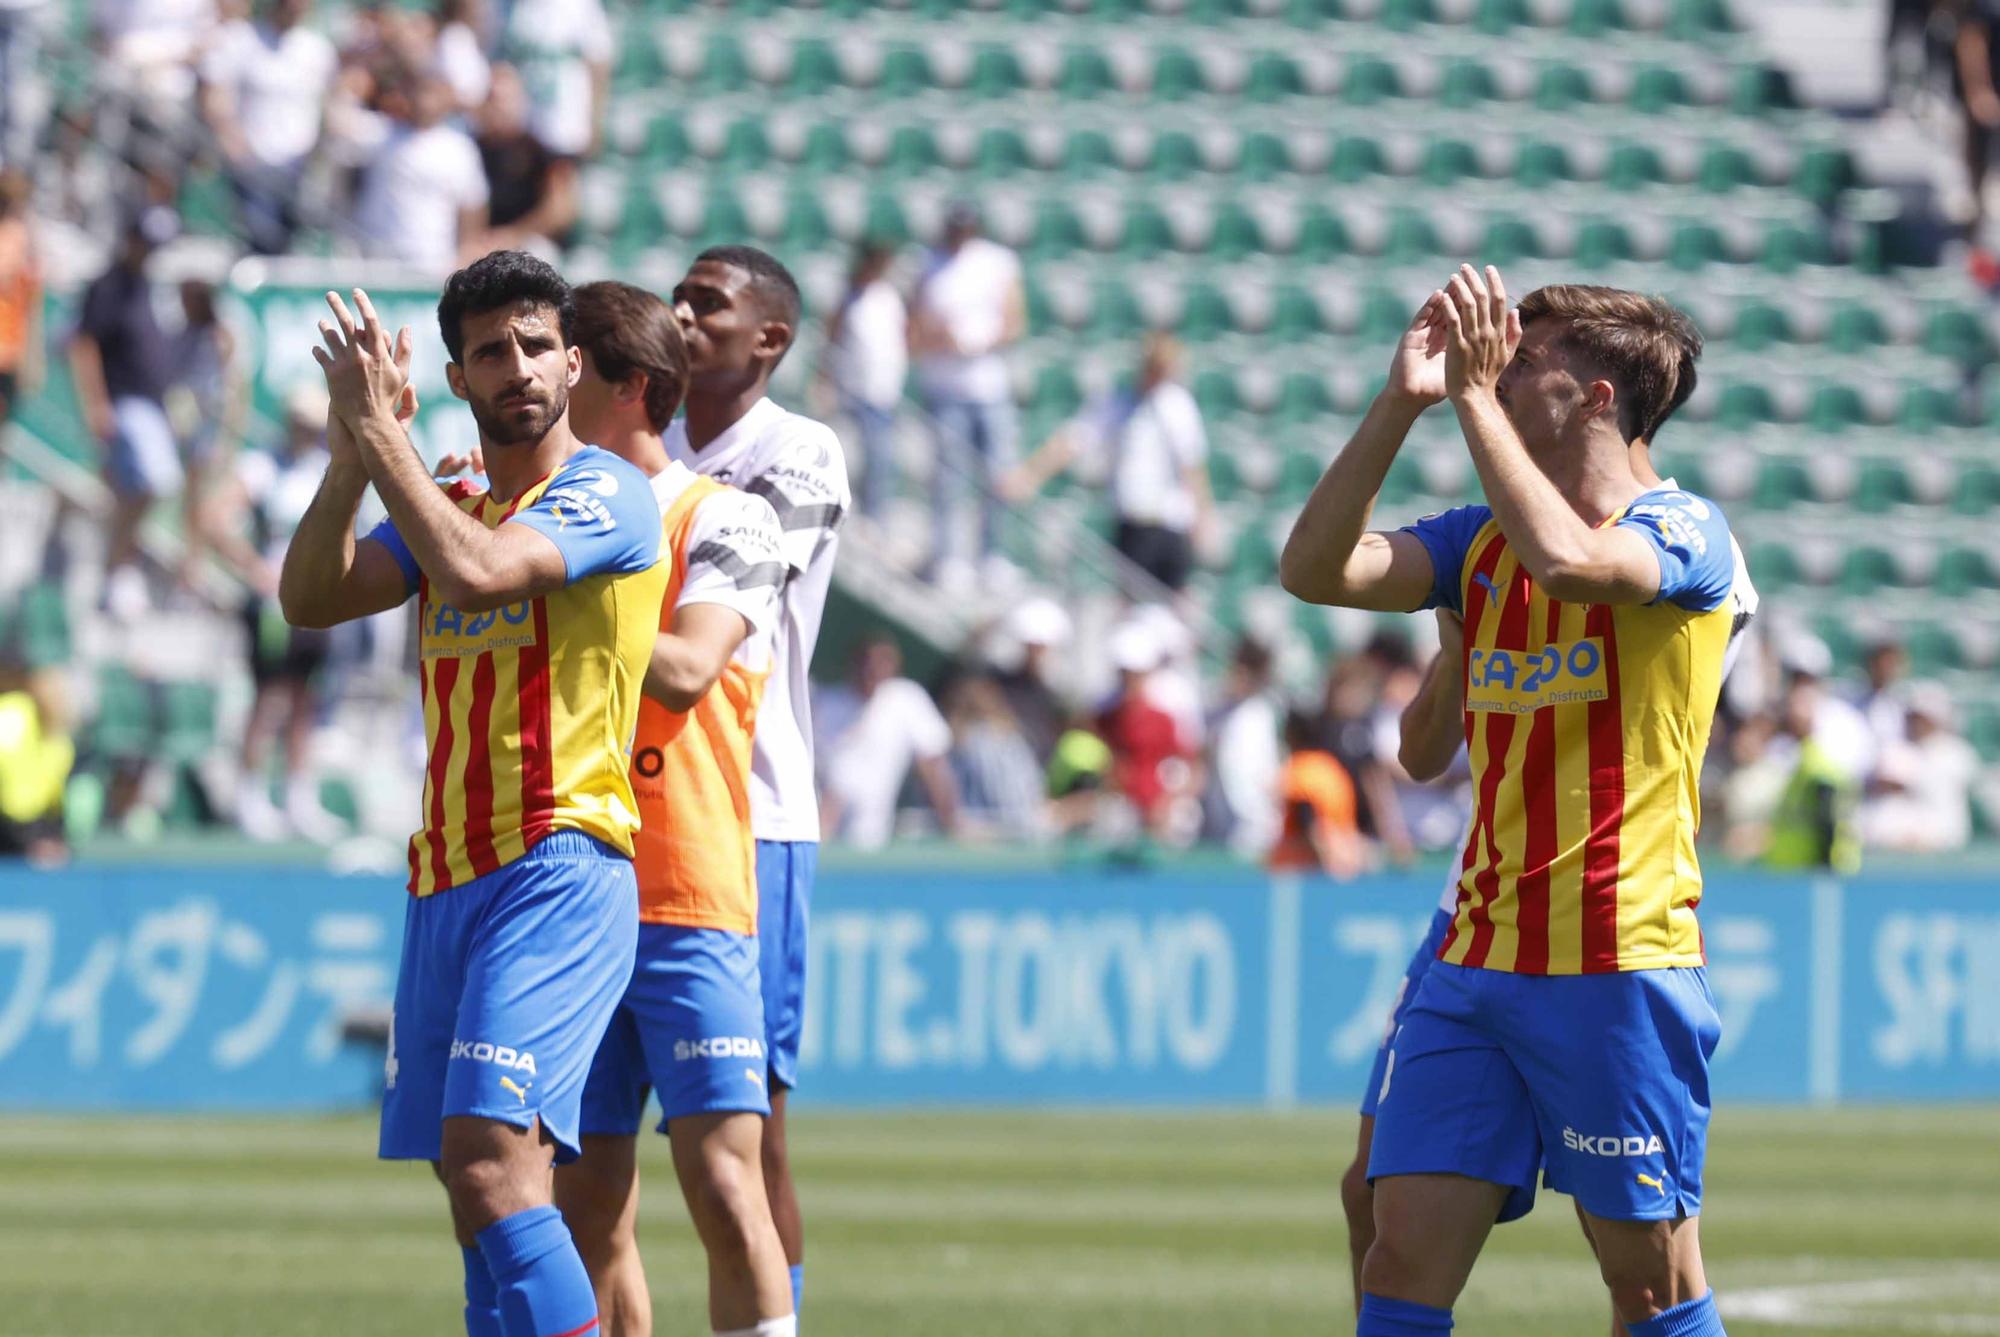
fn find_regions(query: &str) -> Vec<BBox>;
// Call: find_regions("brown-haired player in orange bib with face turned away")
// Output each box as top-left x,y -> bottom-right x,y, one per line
556,282 -> 796,1337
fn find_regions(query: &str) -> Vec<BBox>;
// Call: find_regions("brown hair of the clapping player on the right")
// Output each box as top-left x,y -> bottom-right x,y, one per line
1520,284 -> 1702,442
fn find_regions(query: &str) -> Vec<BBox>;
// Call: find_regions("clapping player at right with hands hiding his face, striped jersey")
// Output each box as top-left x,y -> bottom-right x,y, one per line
1282,266 -> 1736,1337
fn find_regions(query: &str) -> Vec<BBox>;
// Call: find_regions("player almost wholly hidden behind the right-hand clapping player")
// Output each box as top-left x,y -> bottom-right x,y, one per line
1340,318 -> 1760,1337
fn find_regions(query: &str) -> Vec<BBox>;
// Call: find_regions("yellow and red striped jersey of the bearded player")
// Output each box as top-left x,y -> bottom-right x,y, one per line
370,446 -> 670,897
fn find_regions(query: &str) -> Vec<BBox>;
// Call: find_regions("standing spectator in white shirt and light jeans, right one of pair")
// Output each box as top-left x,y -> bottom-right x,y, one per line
910,204 -> 1028,584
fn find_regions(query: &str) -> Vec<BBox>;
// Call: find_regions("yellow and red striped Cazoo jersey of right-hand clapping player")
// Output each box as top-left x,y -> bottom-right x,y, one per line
1408,490 -> 1736,975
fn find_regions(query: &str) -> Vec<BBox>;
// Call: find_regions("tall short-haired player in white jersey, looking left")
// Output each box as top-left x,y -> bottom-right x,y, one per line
666,246 -> 850,1311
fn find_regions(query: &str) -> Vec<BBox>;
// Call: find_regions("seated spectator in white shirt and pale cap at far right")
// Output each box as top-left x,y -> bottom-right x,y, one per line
1860,683 -> 1980,855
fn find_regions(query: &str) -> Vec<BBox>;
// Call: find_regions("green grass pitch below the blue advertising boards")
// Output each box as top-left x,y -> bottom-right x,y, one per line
0,1107 -> 2000,1337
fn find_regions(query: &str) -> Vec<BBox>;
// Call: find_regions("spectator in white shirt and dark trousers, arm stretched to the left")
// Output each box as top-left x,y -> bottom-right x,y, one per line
1004,334 -> 1216,594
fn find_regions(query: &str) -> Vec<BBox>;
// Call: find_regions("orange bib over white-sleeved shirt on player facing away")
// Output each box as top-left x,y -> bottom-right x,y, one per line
632,460 -> 788,933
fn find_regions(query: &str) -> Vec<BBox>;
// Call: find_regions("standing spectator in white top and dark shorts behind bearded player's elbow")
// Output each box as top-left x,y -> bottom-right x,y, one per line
202,382 -> 342,845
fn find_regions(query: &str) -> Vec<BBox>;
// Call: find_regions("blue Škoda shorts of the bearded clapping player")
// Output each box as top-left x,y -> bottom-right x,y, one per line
378,831 -> 638,1163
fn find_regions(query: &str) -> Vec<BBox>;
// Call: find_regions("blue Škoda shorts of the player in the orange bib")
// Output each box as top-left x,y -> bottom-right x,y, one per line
582,925 -> 770,1137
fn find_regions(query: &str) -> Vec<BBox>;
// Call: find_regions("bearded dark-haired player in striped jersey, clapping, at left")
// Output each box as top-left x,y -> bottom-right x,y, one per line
280,250 -> 670,1337
